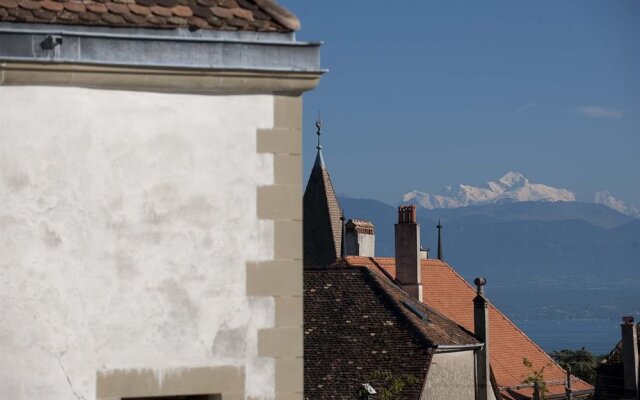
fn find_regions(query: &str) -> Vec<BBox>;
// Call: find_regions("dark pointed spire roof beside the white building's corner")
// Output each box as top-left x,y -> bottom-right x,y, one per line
302,149 -> 342,266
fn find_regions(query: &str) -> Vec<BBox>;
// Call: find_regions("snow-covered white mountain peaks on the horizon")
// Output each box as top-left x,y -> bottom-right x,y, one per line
403,171 -> 640,217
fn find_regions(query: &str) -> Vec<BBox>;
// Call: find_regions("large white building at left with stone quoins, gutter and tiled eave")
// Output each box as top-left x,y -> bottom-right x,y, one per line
0,0 -> 322,400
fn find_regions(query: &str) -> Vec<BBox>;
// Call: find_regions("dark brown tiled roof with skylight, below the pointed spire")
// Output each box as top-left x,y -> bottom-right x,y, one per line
304,266 -> 478,399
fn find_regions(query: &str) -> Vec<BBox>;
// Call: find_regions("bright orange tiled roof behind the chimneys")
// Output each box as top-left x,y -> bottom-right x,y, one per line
346,257 -> 593,399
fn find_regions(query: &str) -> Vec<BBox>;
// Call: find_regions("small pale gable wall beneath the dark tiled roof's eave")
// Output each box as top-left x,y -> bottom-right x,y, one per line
420,351 -> 495,400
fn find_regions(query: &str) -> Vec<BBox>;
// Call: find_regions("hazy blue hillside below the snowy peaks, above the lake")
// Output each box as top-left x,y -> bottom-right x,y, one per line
340,198 -> 640,319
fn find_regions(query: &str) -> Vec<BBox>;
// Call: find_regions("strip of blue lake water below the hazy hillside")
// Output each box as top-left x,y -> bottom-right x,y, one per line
514,319 -> 621,354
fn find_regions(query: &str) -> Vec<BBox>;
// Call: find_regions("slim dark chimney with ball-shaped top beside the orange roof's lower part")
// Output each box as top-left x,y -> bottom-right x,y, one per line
473,278 -> 491,400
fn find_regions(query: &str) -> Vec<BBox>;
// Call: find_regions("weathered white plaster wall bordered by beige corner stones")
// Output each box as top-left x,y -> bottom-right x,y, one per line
0,87 -> 274,399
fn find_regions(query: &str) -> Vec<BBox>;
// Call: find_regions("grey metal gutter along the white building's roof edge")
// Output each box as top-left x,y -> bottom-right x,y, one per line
0,23 -> 325,74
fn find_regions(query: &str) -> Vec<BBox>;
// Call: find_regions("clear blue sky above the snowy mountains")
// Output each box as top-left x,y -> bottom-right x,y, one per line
281,0 -> 640,205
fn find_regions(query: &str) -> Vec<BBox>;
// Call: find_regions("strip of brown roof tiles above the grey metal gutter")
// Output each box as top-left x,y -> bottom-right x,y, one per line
0,0 -> 300,32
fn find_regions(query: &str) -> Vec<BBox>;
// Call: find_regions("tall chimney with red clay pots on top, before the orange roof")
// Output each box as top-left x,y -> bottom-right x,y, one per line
395,205 -> 422,301
